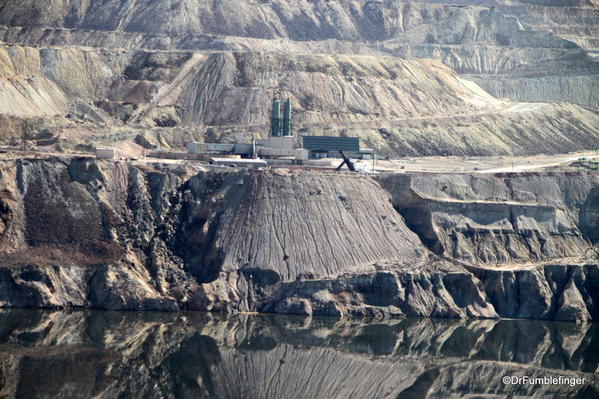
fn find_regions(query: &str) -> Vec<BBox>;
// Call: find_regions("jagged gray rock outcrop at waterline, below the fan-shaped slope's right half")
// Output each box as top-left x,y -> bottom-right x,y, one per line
262,265 -> 498,318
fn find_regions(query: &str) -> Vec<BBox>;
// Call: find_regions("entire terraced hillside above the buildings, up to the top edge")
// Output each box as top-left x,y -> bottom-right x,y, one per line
0,0 -> 599,155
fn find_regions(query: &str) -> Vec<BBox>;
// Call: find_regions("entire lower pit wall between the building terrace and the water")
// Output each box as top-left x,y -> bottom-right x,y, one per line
0,158 -> 599,320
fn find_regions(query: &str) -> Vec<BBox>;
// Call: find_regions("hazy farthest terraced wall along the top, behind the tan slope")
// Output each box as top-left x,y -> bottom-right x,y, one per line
0,0 -> 599,107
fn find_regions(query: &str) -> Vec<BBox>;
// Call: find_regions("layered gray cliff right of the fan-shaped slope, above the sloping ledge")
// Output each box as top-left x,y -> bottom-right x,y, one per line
381,172 -> 599,264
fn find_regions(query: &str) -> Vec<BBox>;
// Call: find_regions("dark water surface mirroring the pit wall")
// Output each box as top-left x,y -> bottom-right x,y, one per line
0,310 -> 599,398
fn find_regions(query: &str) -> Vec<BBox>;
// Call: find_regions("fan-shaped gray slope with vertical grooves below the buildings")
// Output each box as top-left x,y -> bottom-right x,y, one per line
199,172 -> 424,284
